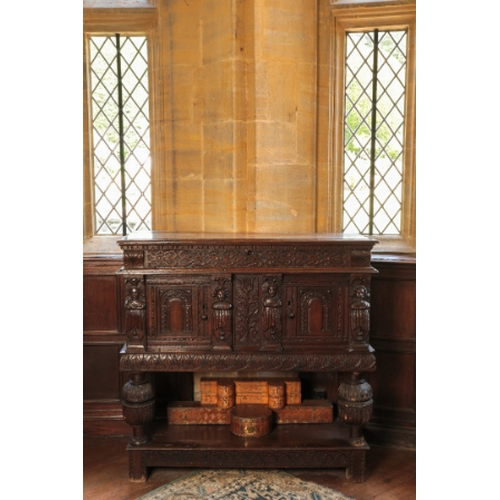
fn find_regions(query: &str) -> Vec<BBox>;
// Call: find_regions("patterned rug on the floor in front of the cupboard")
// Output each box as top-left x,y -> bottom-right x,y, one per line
137,470 -> 353,500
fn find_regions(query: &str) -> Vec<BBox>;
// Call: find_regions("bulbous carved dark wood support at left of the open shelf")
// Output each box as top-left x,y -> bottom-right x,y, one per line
122,373 -> 155,446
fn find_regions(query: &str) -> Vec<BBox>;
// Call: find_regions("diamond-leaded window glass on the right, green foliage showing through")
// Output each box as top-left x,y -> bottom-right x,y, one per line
343,31 -> 407,235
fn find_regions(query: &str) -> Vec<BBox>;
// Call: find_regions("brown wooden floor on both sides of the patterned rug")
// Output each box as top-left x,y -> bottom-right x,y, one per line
83,436 -> 416,500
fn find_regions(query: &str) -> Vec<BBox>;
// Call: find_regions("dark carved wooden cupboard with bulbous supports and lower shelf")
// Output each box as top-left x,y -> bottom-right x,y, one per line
118,232 -> 376,481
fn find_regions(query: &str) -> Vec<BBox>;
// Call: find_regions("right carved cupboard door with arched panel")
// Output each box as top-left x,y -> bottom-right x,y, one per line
283,275 -> 349,350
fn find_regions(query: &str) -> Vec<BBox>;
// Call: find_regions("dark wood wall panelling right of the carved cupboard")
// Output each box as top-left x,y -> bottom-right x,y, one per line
367,257 -> 416,447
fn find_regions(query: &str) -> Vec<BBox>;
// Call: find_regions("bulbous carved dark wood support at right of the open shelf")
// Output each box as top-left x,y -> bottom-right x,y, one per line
338,372 -> 373,446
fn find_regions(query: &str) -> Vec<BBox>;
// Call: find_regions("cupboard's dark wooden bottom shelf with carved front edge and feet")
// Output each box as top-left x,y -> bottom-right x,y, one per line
127,422 -> 369,482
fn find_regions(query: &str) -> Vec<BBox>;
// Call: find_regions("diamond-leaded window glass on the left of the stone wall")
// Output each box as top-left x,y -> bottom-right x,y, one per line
90,36 -> 151,235
